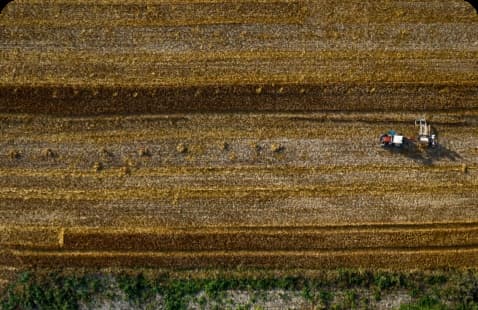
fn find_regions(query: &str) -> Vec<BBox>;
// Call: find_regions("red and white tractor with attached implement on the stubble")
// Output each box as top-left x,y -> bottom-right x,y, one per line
380,118 -> 437,147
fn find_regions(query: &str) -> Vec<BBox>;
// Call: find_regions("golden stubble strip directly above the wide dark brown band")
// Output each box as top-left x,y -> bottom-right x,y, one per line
0,52 -> 478,86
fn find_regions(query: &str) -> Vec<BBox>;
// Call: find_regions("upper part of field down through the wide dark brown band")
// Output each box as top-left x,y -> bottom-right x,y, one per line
0,0 -> 478,116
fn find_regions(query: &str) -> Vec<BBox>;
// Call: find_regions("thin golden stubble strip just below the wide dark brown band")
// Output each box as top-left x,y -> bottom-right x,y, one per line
0,116 -> 478,144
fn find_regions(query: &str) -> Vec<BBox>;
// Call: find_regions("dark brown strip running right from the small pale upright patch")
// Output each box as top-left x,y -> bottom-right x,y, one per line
64,226 -> 478,252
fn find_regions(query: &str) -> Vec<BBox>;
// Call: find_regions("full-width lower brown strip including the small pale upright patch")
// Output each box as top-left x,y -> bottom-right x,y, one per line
0,223 -> 478,252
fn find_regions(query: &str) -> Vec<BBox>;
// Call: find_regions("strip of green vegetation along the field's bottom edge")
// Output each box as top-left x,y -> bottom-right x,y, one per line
0,269 -> 478,310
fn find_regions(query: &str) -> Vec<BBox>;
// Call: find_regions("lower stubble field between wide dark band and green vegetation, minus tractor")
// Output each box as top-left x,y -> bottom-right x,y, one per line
0,112 -> 478,268
